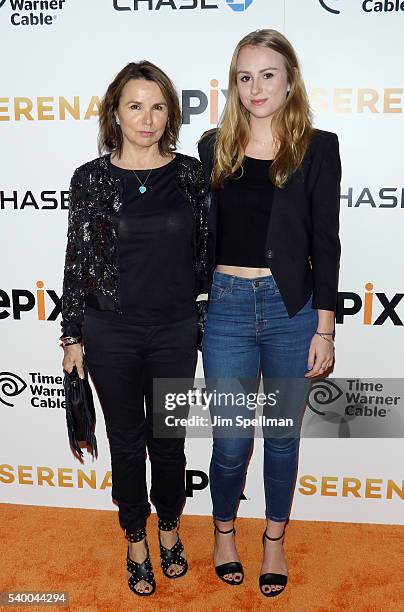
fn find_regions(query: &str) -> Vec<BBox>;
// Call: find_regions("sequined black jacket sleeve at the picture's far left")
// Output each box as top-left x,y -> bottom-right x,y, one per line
61,170 -> 88,338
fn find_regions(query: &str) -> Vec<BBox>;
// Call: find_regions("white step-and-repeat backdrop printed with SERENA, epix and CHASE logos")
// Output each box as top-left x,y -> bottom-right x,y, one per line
0,0 -> 404,523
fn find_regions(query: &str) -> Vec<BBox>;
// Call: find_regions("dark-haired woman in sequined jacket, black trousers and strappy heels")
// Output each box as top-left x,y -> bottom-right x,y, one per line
61,61 -> 207,596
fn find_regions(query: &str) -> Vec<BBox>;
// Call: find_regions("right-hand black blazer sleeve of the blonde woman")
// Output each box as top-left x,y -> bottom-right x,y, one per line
310,134 -> 341,311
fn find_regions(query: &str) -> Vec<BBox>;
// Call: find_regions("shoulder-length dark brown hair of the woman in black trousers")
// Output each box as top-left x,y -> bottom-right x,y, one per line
98,61 -> 181,157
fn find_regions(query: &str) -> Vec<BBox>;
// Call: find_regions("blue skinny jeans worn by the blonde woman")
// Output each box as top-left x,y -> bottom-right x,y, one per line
202,272 -> 318,522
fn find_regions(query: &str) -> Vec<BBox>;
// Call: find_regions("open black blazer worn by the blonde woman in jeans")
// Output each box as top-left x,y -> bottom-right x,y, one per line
198,130 -> 341,318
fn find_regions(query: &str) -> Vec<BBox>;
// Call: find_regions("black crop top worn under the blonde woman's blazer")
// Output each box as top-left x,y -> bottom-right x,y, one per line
216,157 -> 274,268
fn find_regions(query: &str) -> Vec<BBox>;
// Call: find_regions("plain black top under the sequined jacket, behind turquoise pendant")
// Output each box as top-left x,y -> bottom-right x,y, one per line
87,158 -> 196,325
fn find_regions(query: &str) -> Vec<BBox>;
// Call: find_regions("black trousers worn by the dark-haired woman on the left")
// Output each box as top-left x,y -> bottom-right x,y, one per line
83,313 -> 197,532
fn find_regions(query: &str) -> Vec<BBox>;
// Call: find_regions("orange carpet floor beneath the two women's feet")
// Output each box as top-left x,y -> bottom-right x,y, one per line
0,504 -> 404,612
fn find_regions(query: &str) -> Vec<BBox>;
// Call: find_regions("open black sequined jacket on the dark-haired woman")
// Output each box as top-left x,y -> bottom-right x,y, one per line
61,153 -> 208,338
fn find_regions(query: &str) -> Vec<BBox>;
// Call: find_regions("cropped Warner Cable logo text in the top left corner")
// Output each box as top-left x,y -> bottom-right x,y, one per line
0,0 -> 66,26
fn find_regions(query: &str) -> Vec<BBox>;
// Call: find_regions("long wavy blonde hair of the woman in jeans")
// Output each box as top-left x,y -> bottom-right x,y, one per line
212,30 -> 313,189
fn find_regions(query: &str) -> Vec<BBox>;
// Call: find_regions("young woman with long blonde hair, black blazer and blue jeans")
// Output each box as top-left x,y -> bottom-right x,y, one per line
199,30 -> 341,597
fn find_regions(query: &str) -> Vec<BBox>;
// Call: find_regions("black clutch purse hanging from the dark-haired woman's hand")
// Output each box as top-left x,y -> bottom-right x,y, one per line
63,366 -> 98,457
